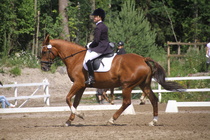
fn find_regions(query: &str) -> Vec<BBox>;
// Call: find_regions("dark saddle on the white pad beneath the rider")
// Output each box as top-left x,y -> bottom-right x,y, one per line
91,52 -> 114,70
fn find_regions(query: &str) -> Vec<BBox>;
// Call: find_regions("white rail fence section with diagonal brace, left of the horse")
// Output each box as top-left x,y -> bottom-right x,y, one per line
0,79 -> 50,108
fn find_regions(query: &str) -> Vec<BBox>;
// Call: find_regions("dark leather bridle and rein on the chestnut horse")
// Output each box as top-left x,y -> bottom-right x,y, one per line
40,44 -> 87,65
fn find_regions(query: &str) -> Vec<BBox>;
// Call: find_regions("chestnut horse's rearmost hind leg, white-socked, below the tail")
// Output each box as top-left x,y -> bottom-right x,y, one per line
140,85 -> 158,126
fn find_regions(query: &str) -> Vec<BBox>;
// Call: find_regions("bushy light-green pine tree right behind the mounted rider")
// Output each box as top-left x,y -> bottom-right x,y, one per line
108,0 -> 156,56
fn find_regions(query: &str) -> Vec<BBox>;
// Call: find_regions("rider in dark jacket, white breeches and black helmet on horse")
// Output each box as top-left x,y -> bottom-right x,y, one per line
85,8 -> 113,85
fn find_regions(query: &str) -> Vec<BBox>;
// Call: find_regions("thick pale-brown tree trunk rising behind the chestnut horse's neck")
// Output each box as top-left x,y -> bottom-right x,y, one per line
59,0 -> 70,41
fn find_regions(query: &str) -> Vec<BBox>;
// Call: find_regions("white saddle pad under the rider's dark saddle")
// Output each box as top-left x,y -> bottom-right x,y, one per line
83,53 -> 116,72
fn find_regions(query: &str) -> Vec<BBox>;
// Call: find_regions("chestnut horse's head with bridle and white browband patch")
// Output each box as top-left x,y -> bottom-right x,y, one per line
40,35 -> 58,71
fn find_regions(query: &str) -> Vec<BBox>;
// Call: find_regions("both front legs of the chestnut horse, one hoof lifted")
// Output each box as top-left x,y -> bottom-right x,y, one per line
66,86 -> 85,126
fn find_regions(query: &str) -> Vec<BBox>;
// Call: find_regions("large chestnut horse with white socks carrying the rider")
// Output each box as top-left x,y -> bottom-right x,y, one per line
40,35 -> 184,126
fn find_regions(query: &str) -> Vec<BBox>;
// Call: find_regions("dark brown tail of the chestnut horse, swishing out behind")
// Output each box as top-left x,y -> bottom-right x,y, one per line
145,57 -> 186,92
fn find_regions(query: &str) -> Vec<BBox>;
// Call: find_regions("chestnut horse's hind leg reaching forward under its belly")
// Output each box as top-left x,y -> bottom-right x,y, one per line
108,88 -> 132,124
